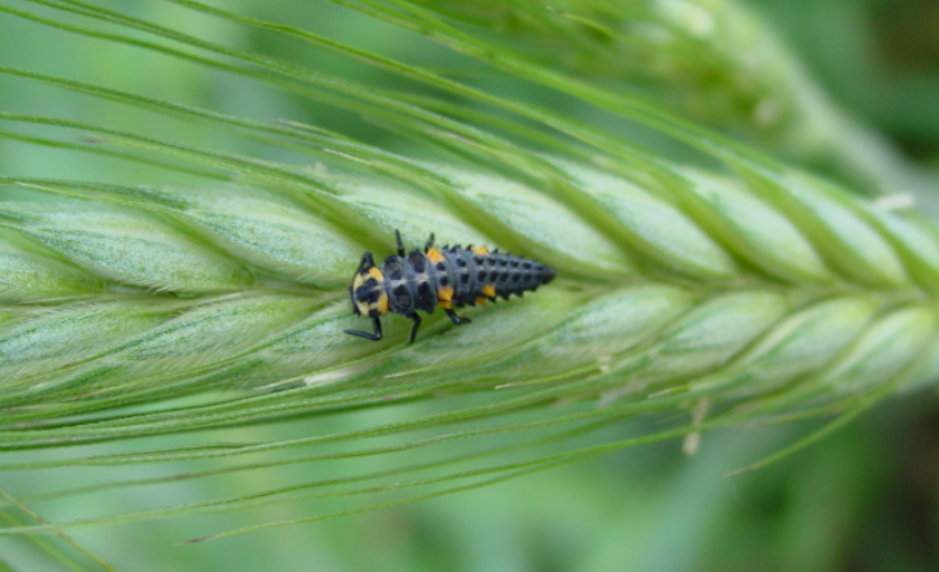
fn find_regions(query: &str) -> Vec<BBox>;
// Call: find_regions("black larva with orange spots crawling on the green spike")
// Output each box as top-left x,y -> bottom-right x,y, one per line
345,230 -> 554,342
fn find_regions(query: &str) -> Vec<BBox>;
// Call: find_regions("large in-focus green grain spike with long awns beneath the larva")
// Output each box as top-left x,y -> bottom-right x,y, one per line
0,0 -> 939,560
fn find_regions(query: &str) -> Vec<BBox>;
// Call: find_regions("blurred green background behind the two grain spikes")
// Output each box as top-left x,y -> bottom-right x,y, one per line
0,0 -> 939,571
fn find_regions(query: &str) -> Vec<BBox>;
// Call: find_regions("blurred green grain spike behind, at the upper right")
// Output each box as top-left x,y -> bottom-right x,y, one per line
422,0 -> 930,198
